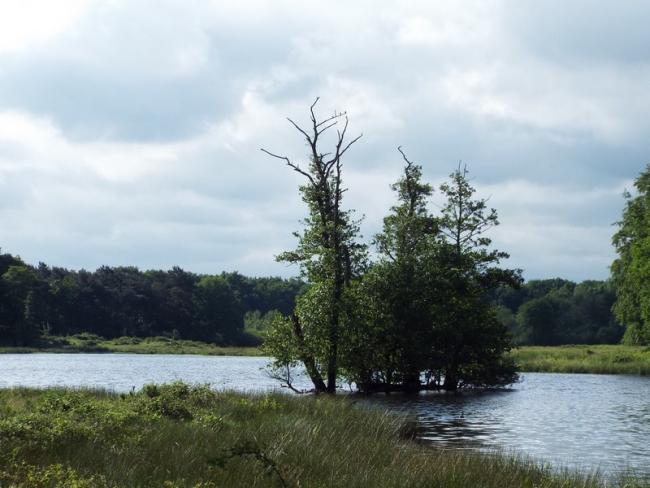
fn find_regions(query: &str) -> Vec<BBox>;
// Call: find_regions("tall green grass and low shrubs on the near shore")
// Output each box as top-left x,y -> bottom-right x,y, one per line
0,383 -> 637,487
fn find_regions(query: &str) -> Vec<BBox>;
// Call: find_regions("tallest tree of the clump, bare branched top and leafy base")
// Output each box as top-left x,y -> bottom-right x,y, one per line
262,99 -> 365,393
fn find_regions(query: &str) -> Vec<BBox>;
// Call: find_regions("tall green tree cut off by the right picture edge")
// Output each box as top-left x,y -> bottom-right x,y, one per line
611,165 -> 650,344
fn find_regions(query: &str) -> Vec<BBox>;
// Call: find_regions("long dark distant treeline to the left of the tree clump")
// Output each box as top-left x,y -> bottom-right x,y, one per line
0,250 -> 304,346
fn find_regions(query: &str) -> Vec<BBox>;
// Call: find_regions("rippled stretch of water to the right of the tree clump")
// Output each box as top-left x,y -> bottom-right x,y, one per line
370,373 -> 650,477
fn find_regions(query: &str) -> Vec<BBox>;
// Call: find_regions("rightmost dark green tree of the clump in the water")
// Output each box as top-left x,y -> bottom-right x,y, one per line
431,167 -> 521,390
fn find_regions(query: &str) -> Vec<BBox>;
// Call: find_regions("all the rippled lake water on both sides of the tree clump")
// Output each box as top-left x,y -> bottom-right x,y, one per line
0,354 -> 650,477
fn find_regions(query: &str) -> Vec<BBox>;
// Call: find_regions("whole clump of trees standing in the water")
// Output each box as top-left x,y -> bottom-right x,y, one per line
265,120 -> 520,392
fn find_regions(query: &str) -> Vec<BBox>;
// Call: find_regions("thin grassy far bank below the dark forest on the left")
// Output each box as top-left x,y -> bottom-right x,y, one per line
0,333 -> 261,356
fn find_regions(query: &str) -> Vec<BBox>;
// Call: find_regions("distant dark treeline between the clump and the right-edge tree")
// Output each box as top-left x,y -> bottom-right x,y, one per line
494,278 -> 625,346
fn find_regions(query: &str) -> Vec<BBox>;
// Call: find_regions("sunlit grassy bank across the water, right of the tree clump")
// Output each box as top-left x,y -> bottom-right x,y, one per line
511,345 -> 650,375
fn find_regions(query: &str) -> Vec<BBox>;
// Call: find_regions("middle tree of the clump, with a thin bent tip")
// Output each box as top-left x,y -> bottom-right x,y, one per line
354,148 -> 438,391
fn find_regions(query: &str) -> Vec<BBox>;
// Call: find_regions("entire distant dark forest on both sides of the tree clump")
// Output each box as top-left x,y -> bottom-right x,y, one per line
0,250 -> 624,346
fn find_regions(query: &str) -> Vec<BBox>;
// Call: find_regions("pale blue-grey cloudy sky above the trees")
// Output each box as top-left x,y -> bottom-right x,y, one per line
0,0 -> 650,280
